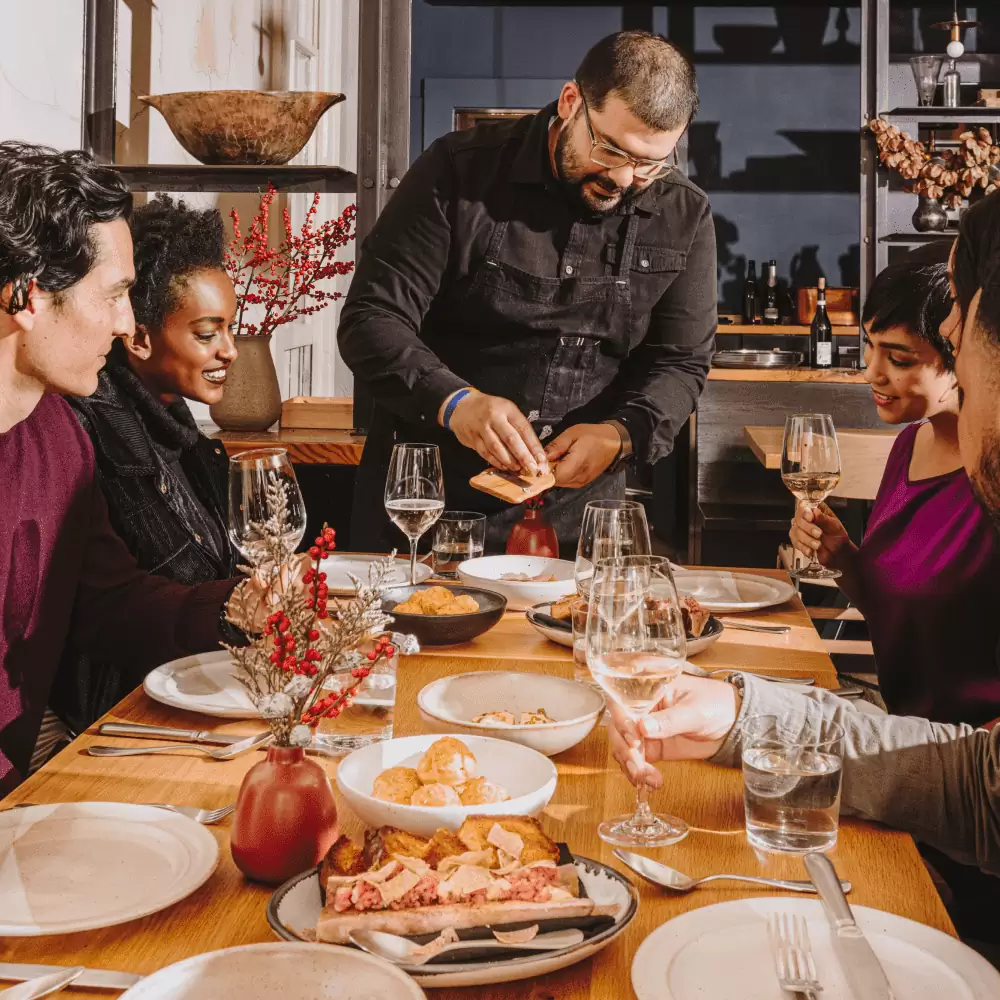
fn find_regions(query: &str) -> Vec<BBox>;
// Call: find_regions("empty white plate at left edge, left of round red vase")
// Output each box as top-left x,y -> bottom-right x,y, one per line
0,802 -> 219,937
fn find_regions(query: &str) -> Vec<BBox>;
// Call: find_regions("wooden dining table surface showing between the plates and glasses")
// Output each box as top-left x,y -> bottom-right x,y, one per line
0,584 -> 953,1000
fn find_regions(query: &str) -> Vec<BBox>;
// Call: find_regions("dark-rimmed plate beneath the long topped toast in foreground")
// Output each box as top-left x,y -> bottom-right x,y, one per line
270,855 -> 639,984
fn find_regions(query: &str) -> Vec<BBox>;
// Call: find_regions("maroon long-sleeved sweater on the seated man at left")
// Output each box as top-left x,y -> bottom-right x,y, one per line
0,396 -> 233,794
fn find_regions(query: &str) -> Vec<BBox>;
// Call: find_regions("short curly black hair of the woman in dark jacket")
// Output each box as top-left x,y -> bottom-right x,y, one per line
131,195 -> 225,330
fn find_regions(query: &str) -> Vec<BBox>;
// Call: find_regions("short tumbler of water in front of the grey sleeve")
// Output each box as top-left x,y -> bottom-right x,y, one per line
743,714 -> 844,854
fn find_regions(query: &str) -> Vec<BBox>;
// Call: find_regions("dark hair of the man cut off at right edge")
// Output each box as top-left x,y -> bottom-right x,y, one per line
952,194 -> 1000,346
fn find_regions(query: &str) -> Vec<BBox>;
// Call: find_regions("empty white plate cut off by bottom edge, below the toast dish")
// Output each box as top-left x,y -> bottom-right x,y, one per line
121,944 -> 427,1000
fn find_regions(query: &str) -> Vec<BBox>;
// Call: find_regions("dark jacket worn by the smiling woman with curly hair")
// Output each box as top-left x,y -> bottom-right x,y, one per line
51,356 -> 236,731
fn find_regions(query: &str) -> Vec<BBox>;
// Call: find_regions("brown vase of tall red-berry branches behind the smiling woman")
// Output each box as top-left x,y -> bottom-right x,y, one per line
211,187 -> 357,430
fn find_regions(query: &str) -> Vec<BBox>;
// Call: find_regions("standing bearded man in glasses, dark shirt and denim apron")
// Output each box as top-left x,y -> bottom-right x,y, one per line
338,31 -> 716,550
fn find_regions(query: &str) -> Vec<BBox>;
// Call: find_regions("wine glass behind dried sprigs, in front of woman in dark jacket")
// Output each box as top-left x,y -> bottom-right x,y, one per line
229,448 -> 306,567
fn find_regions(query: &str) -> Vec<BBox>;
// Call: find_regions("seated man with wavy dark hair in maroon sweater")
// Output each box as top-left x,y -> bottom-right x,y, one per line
0,142 -> 262,794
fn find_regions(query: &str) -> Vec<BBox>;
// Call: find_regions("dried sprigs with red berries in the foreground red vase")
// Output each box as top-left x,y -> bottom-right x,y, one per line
226,477 -> 419,746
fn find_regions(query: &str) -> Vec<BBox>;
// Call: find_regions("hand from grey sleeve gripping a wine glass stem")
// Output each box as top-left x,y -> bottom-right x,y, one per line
608,674 -> 742,788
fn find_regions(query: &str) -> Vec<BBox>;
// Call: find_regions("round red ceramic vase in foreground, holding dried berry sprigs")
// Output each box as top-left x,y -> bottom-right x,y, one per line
230,747 -> 339,885
